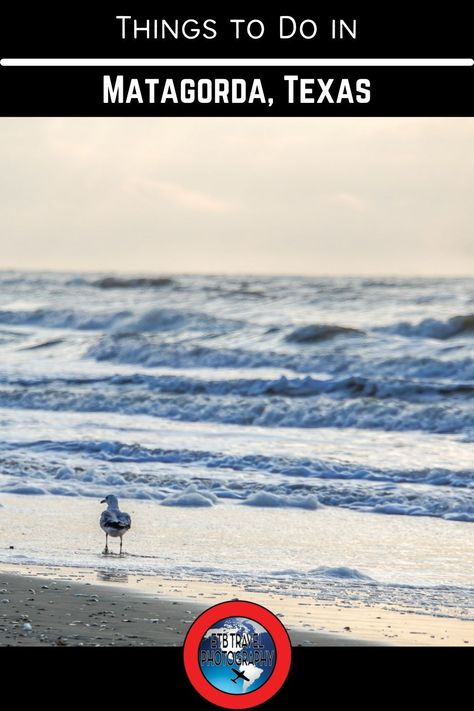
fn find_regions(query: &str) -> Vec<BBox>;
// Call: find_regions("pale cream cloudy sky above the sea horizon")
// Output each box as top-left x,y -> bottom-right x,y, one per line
0,118 -> 474,276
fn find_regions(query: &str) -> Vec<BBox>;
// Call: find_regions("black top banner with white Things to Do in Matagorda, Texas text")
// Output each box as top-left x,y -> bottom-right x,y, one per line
0,2 -> 474,116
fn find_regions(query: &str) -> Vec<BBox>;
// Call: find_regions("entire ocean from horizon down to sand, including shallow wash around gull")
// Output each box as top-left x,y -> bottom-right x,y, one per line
0,271 -> 474,617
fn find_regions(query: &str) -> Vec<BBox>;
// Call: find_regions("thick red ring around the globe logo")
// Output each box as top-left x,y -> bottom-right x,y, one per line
183,600 -> 291,709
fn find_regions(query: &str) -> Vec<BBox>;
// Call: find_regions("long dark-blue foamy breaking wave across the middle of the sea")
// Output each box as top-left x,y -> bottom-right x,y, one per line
0,374 -> 474,434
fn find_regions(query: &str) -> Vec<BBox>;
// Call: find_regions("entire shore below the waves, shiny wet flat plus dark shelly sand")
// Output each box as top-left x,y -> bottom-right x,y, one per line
0,494 -> 474,647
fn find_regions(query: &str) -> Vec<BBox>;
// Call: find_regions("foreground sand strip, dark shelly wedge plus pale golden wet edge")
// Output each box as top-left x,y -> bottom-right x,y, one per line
0,566 -> 474,646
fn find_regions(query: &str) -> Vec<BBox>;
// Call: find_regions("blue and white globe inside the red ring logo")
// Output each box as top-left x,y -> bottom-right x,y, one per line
198,617 -> 276,694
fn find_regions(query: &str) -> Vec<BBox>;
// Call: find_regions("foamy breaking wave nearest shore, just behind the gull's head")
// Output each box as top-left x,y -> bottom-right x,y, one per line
0,442 -> 474,522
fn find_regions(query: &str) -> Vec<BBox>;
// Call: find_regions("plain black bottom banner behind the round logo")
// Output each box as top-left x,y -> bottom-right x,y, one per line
0,647 -> 472,709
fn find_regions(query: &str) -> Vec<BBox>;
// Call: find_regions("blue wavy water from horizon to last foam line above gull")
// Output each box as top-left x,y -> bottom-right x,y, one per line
0,272 -> 474,523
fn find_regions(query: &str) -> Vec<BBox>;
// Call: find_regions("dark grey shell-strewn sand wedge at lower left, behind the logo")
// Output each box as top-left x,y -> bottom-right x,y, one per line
0,573 -> 366,647
